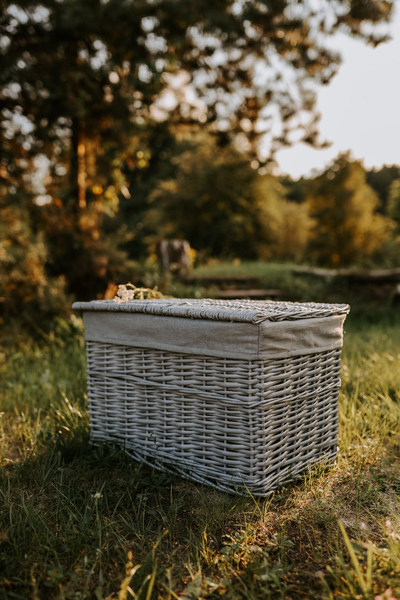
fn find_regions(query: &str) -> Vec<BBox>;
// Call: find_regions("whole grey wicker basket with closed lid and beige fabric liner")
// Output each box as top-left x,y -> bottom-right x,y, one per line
73,299 -> 349,495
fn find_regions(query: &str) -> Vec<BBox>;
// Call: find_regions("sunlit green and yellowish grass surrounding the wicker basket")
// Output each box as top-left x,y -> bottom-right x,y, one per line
0,315 -> 400,600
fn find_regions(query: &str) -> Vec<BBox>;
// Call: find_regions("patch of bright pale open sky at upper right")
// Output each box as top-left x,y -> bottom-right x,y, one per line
277,2 -> 400,178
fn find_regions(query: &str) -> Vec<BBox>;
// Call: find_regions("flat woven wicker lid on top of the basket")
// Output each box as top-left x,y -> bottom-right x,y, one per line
72,298 -> 350,324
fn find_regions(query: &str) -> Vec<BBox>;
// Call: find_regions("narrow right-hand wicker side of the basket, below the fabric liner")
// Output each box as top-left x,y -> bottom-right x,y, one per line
250,350 -> 340,492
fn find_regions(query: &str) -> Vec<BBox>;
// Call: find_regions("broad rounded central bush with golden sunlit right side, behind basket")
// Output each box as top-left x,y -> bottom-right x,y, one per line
143,136 -> 311,261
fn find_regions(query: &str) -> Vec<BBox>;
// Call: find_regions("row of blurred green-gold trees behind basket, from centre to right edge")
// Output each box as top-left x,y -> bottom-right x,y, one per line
119,136 -> 400,267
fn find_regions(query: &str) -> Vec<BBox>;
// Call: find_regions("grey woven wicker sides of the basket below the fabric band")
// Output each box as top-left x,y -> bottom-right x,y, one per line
87,342 -> 340,495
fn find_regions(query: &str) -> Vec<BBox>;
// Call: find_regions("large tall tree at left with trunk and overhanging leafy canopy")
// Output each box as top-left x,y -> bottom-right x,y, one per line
0,0 -> 392,297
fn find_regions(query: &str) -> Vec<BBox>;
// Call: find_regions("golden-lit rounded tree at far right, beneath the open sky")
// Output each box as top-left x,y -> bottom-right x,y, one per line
307,155 -> 394,267
